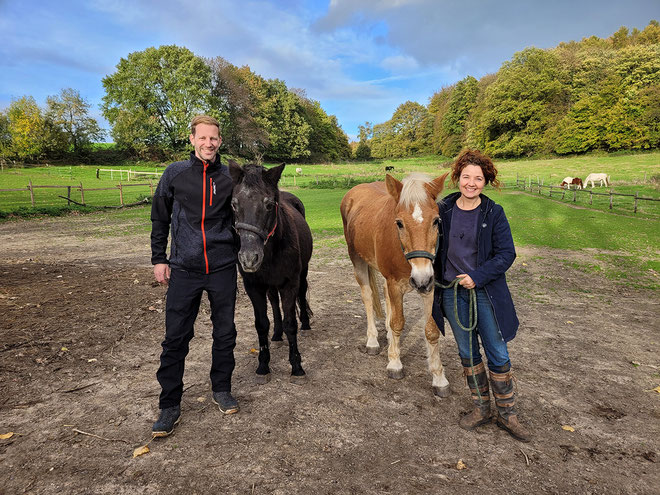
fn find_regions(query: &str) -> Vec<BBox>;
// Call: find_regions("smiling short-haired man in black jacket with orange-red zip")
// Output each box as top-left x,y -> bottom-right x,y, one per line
151,115 -> 238,437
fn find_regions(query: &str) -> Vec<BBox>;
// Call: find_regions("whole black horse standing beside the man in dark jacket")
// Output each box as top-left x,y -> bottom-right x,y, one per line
229,160 -> 312,383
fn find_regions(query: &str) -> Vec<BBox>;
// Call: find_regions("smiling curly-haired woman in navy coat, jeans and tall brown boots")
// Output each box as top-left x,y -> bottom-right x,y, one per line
433,150 -> 530,442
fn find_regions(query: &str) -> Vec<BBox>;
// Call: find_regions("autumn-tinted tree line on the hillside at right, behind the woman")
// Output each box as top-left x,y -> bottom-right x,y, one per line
356,20 -> 660,158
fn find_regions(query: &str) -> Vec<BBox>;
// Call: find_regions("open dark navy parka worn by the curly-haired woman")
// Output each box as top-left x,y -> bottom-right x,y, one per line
433,192 -> 519,342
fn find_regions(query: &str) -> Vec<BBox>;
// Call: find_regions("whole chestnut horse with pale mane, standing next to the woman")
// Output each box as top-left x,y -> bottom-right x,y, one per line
341,173 -> 449,397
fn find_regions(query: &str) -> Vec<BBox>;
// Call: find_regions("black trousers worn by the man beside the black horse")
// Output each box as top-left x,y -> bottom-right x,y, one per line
156,265 -> 236,409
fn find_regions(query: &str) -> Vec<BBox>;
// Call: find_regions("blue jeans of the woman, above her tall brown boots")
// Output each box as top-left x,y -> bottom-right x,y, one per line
442,286 -> 509,370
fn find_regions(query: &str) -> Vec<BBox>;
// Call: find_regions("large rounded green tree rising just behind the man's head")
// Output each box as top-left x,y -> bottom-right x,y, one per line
102,45 -> 217,154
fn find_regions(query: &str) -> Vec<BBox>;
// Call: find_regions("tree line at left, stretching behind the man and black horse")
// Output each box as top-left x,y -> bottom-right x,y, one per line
0,45 -> 351,162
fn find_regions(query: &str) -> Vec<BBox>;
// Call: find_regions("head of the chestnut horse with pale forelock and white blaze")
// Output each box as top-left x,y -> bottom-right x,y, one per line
385,173 -> 448,293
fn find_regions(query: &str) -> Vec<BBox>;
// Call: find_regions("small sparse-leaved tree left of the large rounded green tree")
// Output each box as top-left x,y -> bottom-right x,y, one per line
46,88 -> 104,153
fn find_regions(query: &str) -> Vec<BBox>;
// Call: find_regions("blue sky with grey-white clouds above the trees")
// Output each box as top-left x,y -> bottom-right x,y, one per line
0,0 -> 660,138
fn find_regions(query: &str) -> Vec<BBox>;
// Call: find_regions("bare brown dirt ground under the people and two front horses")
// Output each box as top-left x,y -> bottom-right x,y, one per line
0,211 -> 660,495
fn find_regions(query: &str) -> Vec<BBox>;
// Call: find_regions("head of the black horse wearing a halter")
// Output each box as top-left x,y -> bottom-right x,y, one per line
229,160 -> 284,272
